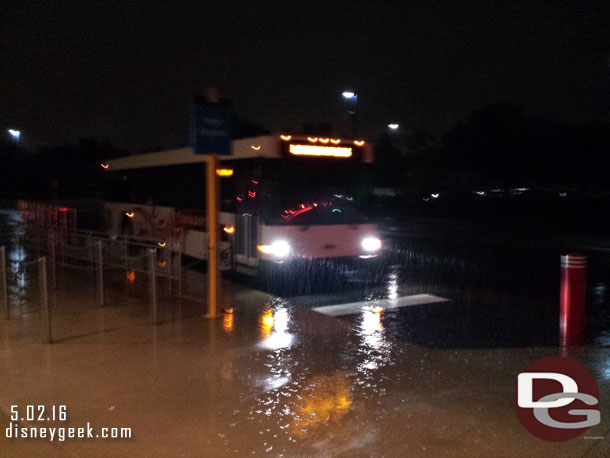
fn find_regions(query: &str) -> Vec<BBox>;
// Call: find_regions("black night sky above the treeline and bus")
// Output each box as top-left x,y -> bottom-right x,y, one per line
0,0 -> 610,150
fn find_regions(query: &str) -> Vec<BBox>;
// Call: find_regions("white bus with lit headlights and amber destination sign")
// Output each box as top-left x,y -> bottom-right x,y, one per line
101,135 -> 382,275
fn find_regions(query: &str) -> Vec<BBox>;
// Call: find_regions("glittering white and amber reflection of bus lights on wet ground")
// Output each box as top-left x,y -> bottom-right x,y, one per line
238,298 -> 400,453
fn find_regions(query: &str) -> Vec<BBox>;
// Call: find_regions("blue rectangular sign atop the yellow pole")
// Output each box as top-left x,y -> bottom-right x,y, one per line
190,97 -> 231,155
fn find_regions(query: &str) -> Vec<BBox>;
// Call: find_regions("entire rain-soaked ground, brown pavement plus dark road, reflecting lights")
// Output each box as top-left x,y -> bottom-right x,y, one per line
0,210 -> 610,458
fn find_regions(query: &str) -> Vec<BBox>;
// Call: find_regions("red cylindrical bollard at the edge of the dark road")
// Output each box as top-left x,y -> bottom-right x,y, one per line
559,254 -> 587,347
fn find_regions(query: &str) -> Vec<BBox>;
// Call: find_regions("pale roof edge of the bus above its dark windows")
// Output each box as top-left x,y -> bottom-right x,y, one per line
108,135 -> 369,171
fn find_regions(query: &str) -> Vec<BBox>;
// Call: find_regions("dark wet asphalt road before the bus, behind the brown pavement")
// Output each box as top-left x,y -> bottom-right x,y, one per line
243,213 -> 610,348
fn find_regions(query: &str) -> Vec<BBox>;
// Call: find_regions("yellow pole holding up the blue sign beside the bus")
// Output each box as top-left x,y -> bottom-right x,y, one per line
205,154 -> 220,318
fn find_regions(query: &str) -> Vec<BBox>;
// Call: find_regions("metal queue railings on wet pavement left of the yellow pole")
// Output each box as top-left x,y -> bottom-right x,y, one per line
0,219 -> 184,343
